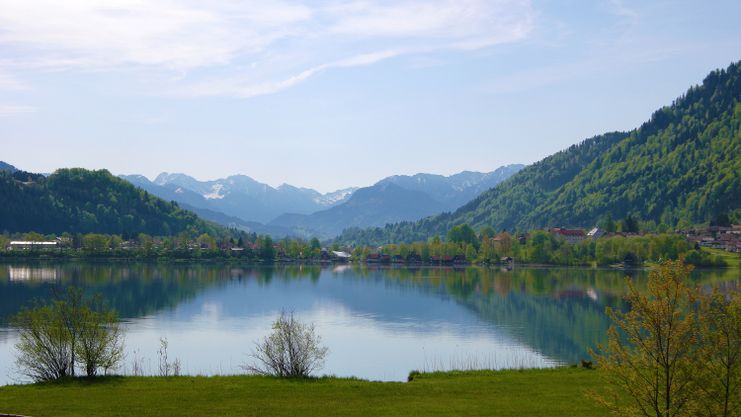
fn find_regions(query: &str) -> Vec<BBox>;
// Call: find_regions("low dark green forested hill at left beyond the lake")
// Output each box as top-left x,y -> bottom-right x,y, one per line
0,168 -> 219,236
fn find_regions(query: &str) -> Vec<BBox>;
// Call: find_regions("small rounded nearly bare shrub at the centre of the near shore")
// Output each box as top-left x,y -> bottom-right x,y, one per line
242,311 -> 329,378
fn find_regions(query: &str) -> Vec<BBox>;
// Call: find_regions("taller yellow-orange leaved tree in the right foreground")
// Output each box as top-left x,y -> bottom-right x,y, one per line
595,261 -> 697,417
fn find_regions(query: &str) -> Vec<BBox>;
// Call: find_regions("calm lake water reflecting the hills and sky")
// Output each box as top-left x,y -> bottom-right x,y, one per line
0,263 -> 740,385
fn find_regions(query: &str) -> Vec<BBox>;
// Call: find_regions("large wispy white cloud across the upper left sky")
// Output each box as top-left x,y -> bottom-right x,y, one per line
0,0 -> 534,97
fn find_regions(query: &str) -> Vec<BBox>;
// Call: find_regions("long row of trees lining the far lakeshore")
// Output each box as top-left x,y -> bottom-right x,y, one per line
0,220 -> 725,266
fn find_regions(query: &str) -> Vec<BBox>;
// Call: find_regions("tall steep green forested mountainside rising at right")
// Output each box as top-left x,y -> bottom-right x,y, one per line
339,62 -> 741,243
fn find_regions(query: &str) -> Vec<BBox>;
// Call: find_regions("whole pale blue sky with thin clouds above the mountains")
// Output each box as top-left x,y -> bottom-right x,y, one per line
0,0 -> 741,192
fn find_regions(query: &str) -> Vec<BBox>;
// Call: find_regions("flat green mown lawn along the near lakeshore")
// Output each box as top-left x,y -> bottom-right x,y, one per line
0,368 -> 605,417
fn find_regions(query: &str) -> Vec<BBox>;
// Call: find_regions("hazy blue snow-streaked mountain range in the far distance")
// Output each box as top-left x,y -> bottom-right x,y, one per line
121,165 -> 523,238
